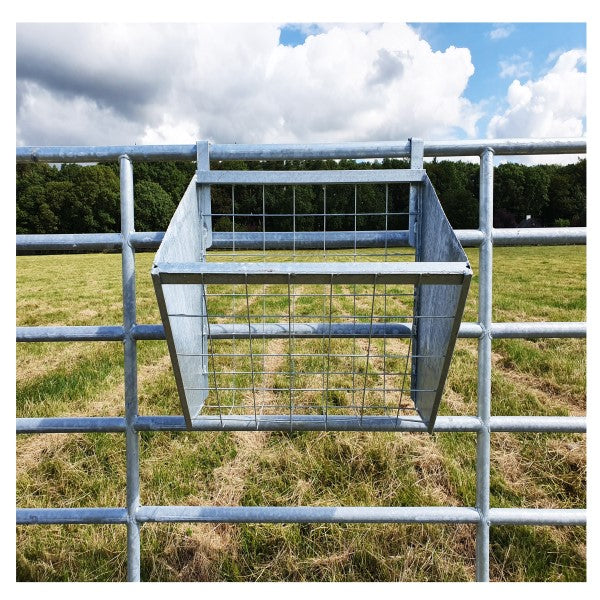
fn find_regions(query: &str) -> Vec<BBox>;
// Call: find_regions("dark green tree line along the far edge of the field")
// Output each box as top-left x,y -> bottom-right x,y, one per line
16,159 -> 586,234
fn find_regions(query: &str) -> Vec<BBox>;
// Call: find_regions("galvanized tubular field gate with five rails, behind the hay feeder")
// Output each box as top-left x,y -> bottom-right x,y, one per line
16,138 -> 586,581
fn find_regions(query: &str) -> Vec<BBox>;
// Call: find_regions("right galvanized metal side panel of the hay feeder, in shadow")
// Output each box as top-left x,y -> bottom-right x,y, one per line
411,179 -> 472,431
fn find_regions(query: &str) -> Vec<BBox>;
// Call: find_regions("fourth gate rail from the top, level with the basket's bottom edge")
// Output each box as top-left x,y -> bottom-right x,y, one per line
16,415 -> 587,434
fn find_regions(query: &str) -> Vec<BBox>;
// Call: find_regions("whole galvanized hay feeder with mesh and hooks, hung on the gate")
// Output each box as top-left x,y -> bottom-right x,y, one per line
152,159 -> 472,430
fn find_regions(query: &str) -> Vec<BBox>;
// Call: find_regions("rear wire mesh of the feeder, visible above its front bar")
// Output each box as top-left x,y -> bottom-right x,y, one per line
207,183 -> 415,261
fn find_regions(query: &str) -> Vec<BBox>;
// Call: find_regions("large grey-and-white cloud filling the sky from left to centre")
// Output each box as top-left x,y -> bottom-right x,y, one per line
17,23 -> 481,145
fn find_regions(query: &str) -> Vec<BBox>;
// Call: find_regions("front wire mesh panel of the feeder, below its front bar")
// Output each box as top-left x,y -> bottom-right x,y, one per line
183,282 -> 422,419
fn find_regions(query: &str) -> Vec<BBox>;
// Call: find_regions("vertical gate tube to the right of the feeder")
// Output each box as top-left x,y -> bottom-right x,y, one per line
475,148 -> 494,581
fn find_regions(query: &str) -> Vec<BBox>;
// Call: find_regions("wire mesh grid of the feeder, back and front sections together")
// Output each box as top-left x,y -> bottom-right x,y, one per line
203,184 -> 415,423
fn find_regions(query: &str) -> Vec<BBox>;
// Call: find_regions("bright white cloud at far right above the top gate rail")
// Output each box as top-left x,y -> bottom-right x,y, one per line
487,49 -> 586,162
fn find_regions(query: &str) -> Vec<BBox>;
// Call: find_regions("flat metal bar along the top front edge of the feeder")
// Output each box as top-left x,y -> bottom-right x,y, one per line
153,262 -> 471,285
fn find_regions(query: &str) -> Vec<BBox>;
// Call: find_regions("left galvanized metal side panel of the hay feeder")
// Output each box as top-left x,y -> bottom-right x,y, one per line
152,180 -> 208,427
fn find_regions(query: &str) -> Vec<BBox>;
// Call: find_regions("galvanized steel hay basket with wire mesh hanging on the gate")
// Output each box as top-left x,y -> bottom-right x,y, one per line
152,139 -> 472,431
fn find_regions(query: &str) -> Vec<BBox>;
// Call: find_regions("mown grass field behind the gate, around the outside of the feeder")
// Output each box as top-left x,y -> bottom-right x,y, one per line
16,247 -> 586,581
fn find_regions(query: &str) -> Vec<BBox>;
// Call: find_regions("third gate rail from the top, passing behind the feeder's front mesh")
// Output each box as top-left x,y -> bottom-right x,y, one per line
16,321 -> 587,342
